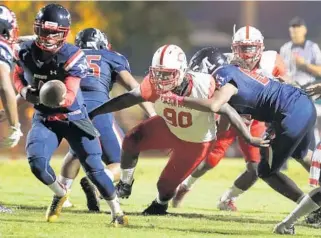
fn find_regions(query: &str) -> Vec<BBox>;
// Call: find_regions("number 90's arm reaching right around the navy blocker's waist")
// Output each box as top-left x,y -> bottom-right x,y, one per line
217,103 -> 270,147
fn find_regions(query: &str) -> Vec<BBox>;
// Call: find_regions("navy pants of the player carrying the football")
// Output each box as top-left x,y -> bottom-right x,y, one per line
26,115 -> 115,200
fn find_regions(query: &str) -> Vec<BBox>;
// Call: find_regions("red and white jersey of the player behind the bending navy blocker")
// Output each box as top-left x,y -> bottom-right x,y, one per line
225,50 -> 286,78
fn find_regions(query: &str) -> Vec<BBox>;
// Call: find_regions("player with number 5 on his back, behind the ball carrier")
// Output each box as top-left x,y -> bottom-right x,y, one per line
59,28 -> 155,211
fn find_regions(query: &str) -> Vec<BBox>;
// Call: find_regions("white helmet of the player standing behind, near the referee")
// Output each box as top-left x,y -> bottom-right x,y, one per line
231,26 -> 264,62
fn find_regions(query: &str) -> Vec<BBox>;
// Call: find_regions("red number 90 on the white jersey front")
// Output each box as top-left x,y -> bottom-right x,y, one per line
163,108 -> 193,128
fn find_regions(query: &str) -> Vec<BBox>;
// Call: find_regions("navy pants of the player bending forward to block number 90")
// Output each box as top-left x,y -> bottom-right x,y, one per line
258,94 -> 316,178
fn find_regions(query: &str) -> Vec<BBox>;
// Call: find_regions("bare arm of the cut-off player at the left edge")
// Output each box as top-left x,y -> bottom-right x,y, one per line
0,64 -> 19,127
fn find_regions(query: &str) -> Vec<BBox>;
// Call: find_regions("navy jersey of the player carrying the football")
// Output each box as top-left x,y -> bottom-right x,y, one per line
17,41 -> 88,118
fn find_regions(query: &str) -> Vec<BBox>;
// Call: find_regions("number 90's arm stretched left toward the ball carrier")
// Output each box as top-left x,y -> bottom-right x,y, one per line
89,86 -> 145,118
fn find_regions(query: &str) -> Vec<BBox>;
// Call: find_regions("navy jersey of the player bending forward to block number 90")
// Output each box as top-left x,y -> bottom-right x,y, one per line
213,65 -> 304,122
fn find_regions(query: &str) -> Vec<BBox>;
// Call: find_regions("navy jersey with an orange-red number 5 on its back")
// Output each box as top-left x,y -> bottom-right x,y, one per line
80,49 -> 130,103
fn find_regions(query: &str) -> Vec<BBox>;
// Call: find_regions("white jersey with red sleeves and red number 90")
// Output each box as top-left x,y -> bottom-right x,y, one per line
140,72 -> 216,143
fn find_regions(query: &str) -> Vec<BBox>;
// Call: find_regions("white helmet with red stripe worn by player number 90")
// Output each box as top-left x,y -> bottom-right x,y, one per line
149,45 -> 187,94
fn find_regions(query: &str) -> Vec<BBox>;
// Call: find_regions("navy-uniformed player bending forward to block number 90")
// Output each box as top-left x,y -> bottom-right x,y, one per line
161,48 -> 316,229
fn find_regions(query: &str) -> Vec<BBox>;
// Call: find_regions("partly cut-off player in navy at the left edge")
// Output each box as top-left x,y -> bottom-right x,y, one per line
0,6 -> 22,213
